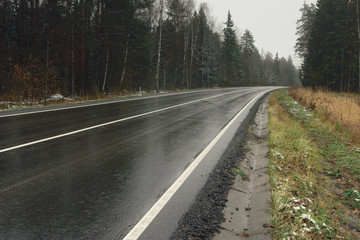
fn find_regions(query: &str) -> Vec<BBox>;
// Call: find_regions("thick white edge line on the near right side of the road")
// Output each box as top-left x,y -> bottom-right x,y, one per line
124,90 -> 271,240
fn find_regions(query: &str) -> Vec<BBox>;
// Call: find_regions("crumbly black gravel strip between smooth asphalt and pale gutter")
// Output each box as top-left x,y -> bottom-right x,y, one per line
170,91 -> 272,239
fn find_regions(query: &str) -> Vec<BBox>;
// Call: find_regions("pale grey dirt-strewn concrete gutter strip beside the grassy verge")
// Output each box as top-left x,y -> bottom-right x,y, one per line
214,98 -> 271,240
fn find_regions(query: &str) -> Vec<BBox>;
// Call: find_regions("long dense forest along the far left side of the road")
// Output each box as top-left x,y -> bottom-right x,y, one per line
0,0 -> 296,100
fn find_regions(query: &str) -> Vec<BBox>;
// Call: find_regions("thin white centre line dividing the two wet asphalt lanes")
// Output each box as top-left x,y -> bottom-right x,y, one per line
0,90 -> 243,153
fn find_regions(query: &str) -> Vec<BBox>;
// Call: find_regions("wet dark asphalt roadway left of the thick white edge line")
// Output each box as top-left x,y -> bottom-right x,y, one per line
0,88 -> 276,239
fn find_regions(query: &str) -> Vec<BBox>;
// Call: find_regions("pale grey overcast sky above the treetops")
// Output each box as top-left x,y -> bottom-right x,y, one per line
197,0 -> 316,65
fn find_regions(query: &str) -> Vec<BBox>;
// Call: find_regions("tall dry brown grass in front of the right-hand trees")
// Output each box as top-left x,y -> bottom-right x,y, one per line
289,87 -> 360,145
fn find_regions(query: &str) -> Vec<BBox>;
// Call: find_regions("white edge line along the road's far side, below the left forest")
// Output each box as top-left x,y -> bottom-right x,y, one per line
0,90 -> 222,118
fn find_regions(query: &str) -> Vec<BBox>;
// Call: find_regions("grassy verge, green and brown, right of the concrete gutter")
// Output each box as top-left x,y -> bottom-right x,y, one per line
269,88 -> 360,239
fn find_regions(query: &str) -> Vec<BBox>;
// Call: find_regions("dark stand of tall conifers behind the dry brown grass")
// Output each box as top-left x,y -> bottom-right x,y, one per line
295,0 -> 360,91
